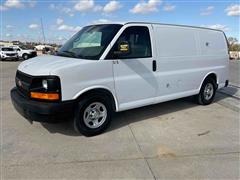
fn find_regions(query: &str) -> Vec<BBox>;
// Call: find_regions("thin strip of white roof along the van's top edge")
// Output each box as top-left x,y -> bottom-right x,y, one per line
91,21 -> 224,33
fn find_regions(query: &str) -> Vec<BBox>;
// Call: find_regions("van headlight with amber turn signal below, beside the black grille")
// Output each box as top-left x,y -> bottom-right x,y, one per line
30,76 -> 61,101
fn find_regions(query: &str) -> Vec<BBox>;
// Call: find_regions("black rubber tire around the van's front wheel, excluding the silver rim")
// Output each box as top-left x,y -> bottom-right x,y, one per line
73,94 -> 113,136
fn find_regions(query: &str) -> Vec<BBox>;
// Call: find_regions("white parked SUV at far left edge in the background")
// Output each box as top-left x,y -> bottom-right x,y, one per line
0,47 -> 18,61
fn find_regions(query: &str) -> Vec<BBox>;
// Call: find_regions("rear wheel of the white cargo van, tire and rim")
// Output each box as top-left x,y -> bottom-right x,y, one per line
196,78 -> 217,105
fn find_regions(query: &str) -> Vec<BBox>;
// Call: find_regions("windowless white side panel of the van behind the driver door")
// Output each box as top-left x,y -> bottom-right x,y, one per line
153,25 -> 228,102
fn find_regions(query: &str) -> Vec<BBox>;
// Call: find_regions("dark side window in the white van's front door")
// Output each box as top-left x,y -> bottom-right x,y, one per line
106,26 -> 152,59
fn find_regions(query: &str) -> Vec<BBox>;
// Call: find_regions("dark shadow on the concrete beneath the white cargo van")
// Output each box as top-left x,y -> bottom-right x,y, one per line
42,93 -> 233,136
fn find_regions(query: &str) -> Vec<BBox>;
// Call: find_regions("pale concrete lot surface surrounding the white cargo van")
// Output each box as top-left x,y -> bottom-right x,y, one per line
0,62 -> 240,179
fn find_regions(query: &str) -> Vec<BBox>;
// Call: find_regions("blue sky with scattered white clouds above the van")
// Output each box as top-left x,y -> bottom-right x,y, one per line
0,0 -> 240,43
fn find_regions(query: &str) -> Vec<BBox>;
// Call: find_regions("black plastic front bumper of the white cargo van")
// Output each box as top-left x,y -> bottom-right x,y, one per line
11,87 -> 75,123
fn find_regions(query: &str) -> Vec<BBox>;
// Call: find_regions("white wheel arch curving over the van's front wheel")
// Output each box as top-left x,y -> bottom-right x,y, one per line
74,86 -> 118,111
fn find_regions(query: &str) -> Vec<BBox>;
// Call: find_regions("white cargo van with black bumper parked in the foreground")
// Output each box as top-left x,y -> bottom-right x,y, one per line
11,22 -> 229,136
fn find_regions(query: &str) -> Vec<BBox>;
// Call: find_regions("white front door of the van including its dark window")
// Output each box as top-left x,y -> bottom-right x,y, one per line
106,25 -> 158,110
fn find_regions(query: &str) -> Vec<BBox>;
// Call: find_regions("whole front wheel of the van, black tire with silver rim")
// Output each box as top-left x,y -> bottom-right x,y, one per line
74,95 -> 112,136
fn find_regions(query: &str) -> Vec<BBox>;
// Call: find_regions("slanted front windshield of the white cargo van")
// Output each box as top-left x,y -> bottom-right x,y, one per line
57,24 -> 122,60
